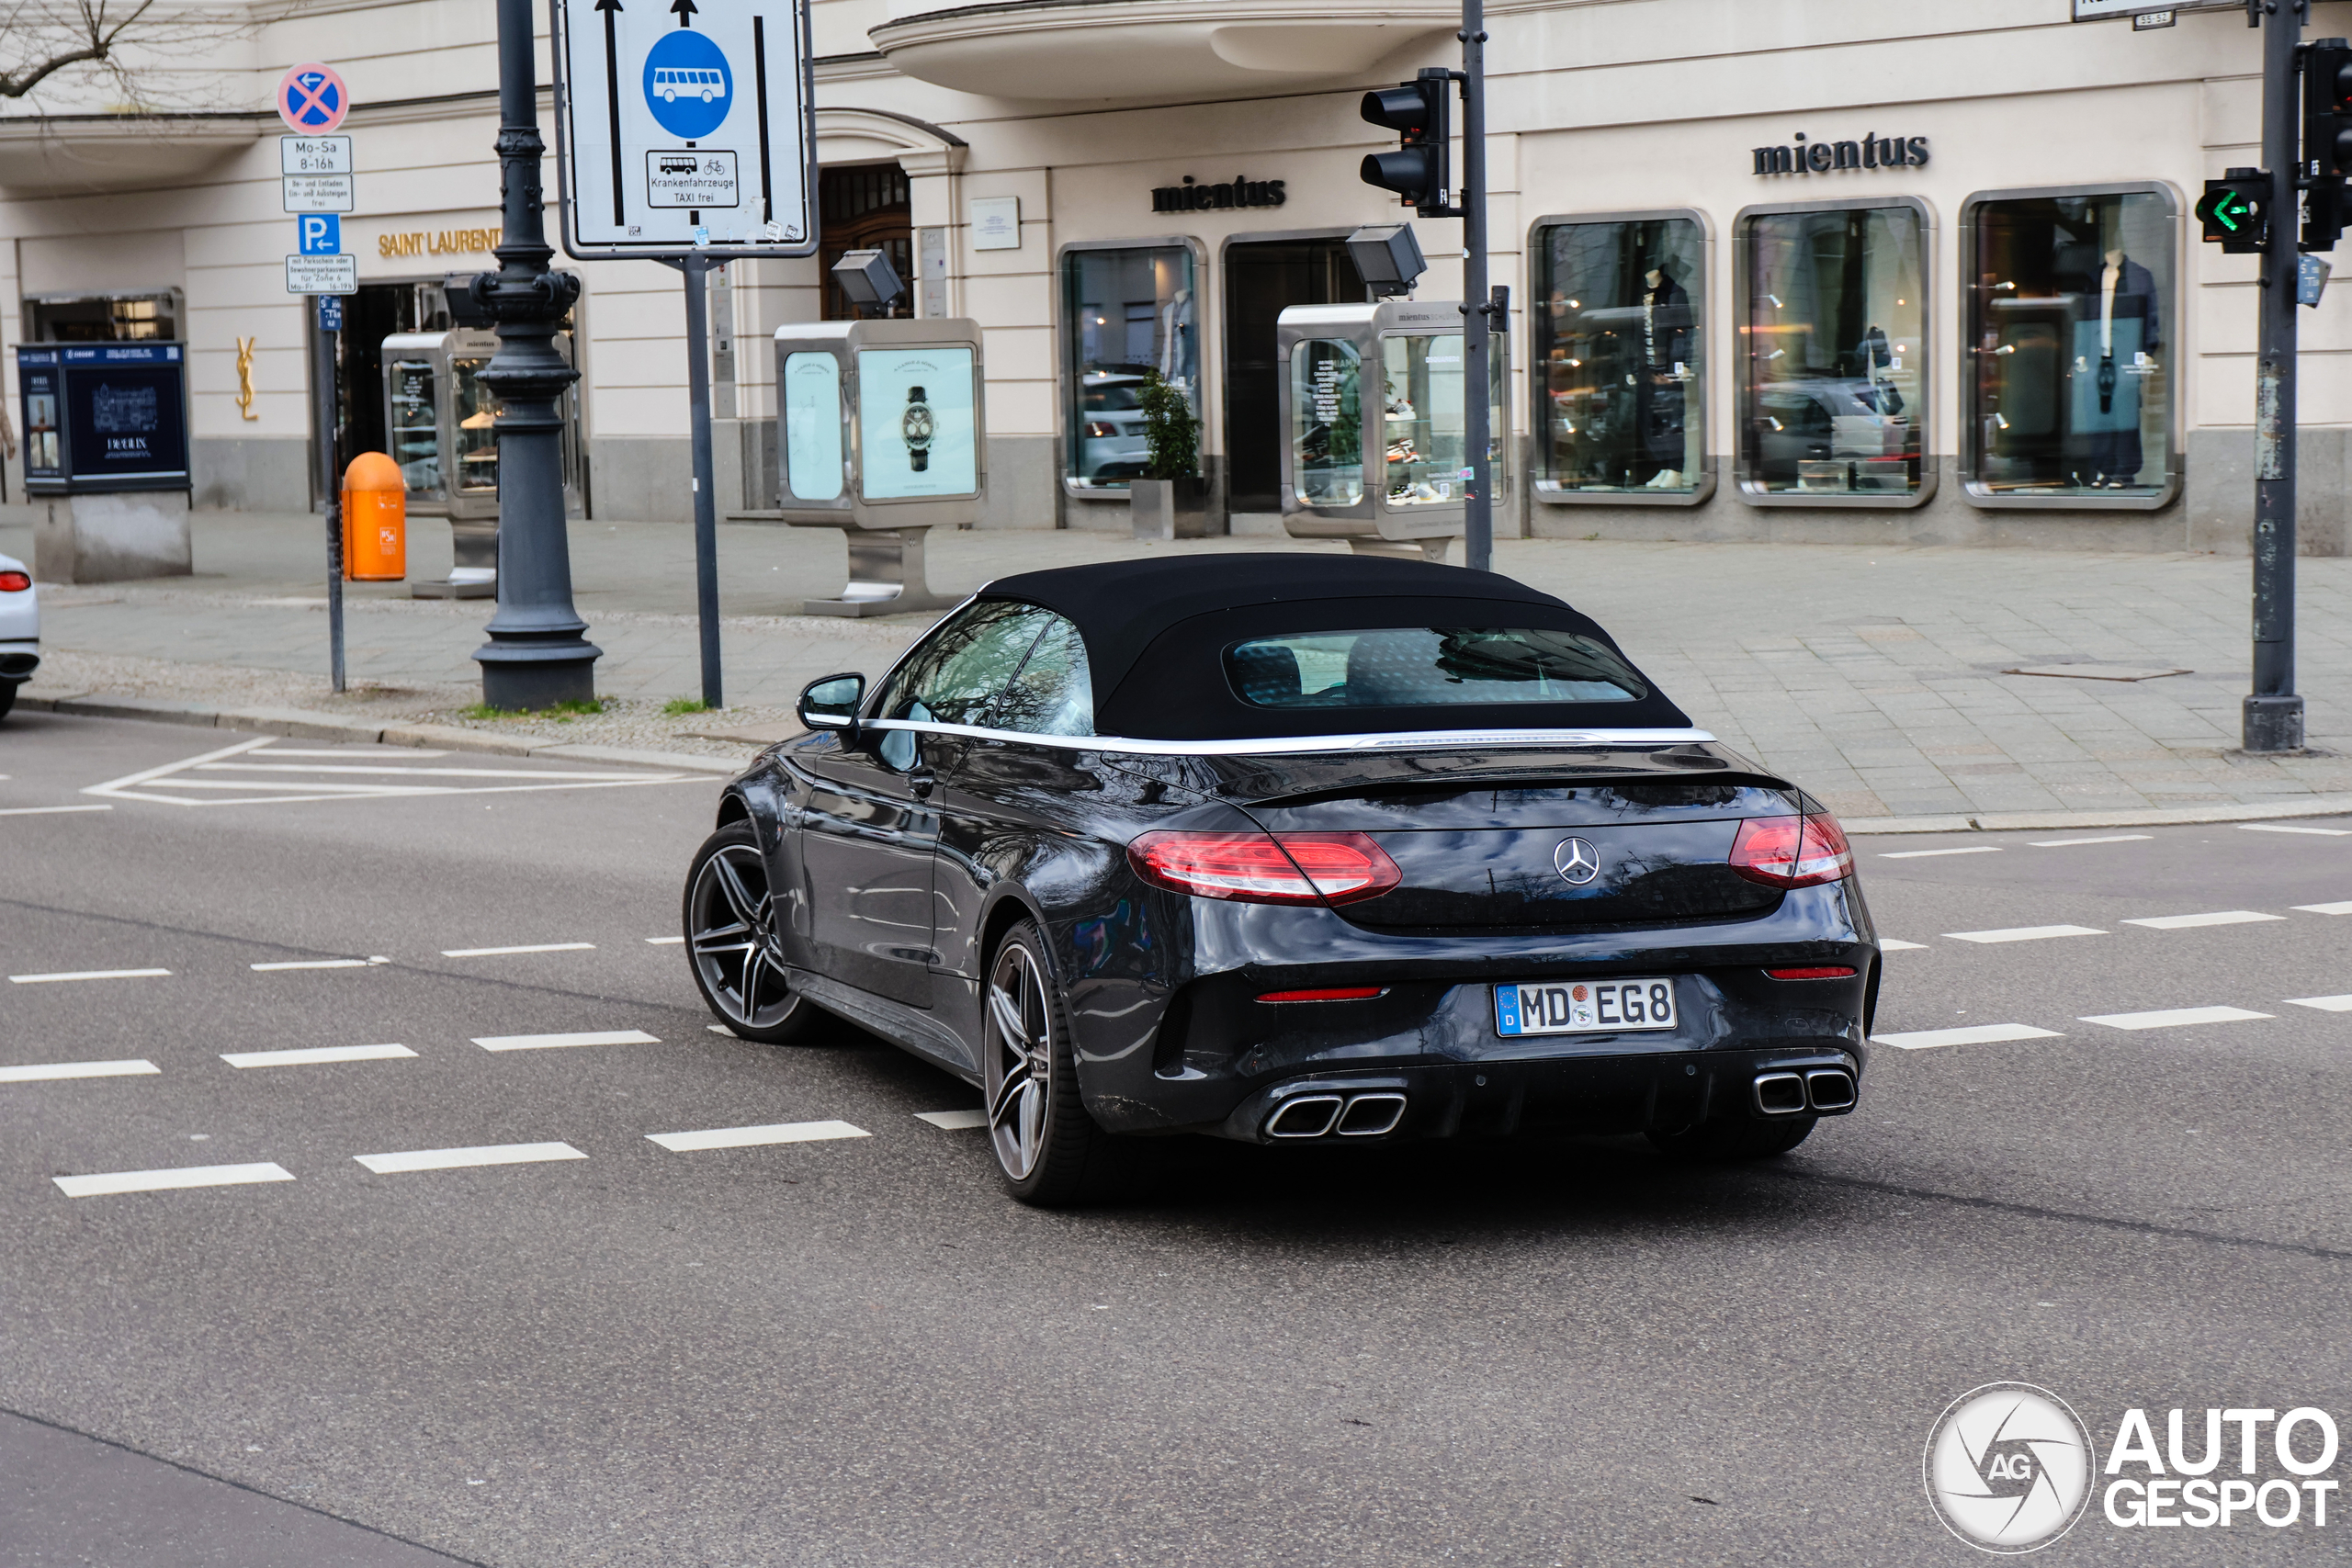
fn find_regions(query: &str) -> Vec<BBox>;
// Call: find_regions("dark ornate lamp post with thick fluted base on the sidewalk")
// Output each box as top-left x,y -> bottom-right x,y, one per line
468,0 -> 605,707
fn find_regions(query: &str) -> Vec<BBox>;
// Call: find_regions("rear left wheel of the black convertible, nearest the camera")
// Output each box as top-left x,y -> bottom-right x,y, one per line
981,919 -> 1110,1208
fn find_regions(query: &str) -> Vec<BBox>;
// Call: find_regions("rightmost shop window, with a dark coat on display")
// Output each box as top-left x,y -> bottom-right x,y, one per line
1964,190 -> 2178,501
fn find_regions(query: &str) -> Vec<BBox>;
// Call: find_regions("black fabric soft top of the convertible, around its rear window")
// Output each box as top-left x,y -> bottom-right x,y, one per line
978,550 -> 1691,740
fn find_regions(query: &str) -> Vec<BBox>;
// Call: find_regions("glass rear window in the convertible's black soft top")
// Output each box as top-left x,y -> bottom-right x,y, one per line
1226,626 -> 1649,707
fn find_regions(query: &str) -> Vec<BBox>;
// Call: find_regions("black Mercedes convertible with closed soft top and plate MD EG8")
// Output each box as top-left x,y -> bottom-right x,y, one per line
684,552 -> 1879,1203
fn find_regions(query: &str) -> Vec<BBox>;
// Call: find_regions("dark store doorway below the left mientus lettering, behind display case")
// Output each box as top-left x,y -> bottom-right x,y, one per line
1226,235 -> 1364,513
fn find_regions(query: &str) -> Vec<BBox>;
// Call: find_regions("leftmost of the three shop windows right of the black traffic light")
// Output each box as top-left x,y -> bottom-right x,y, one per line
1533,219 -> 1708,496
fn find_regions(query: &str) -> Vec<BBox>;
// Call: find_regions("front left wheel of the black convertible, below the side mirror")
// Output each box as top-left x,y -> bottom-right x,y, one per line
680,820 -> 823,1046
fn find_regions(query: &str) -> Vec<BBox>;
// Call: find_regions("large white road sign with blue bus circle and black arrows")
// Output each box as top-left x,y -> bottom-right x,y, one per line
553,0 -> 816,261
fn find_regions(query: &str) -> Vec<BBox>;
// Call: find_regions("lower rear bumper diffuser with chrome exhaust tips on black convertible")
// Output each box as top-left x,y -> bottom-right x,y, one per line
1200,1046 -> 1860,1145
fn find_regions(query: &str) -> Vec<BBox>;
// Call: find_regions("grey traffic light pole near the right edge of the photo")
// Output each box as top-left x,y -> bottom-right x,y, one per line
2244,0 -> 2305,752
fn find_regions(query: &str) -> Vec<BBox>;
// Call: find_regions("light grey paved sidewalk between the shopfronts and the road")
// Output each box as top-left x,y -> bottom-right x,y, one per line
0,510 -> 2352,825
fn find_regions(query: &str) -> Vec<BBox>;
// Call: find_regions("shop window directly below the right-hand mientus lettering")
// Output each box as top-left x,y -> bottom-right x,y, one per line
1738,205 -> 1928,503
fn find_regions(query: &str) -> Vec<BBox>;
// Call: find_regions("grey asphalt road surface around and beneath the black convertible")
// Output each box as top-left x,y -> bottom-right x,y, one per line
0,715 -> 2352,1568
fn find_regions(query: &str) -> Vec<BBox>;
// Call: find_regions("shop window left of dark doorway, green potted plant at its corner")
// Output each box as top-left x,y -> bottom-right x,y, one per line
1061,244 -> 1200,493
